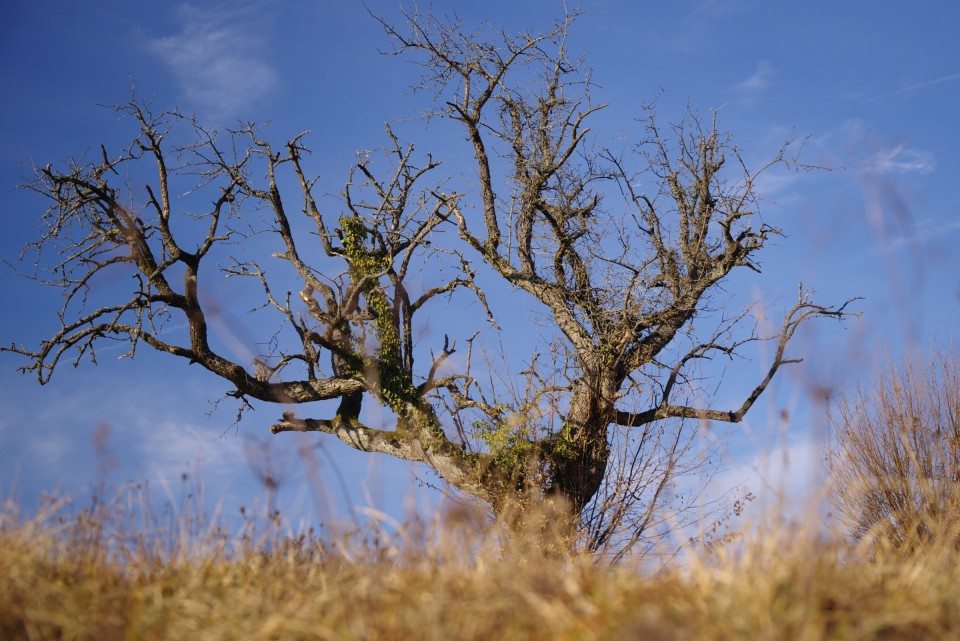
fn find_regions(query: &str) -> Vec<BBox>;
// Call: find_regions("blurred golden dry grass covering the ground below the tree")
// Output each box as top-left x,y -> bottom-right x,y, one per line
0,484 -> 960,641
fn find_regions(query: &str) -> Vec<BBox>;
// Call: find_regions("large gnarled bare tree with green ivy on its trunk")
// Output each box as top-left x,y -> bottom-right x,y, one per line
6,7 -> 849,543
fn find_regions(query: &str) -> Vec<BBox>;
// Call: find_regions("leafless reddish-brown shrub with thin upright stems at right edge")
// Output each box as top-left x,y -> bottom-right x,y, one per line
831,349 -> 960,552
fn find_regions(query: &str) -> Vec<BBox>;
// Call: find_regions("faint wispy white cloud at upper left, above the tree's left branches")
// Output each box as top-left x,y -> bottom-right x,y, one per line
146,5 -> 278,119
